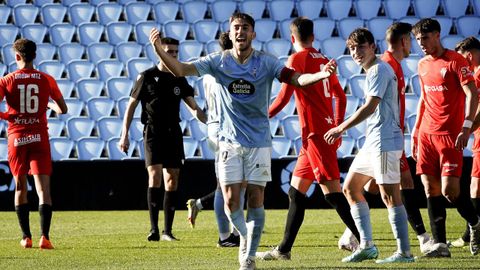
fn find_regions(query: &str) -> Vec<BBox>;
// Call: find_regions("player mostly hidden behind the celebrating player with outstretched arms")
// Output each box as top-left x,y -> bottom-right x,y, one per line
187,32 -> 245,247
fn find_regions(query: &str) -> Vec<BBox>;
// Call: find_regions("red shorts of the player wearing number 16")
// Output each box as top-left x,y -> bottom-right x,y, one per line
8,132 -> 52,176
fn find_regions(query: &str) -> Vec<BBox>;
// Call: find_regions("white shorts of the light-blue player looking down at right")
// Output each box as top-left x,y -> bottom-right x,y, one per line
349,149 -> 402,184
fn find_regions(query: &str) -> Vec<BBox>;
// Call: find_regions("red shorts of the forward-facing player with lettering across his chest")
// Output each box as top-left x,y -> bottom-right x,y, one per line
417,132 -> 463,177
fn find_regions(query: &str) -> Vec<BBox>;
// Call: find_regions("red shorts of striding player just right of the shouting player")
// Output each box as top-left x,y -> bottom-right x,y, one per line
293,136 -> 340,183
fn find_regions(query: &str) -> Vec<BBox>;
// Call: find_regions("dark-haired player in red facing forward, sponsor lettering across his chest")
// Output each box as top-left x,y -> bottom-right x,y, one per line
412,18 -> 480,257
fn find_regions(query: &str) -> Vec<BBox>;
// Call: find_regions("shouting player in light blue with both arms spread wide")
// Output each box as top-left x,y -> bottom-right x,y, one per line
150,13 -> 336,269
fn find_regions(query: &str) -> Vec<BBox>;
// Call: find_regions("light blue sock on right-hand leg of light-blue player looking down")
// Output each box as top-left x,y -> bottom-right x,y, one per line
388,205 -> 410,256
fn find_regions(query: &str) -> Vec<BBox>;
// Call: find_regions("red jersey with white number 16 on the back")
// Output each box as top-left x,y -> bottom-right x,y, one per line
0,68 -> 62,134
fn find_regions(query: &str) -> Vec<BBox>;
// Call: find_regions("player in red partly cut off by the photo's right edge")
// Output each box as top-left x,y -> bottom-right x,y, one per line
449,37 -> 480,247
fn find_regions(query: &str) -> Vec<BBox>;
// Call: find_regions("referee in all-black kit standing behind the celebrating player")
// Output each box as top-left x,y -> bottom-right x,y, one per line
119,37 -> 206,241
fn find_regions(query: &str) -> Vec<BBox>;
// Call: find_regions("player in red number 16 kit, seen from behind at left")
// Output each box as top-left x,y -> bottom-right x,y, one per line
0,39 -> 67,249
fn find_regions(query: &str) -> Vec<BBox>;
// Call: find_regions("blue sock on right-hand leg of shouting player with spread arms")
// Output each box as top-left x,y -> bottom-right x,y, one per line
247,206 -> 265,258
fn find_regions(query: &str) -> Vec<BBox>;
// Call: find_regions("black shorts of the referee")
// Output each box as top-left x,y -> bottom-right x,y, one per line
143,124 -> 185,168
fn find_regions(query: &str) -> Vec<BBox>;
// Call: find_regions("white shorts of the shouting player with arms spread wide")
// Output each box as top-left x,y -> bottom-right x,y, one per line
217,141 -> 272,186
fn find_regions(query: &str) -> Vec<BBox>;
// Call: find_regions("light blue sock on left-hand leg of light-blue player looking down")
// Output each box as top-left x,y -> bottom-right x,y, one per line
350,202 -> 373,248
